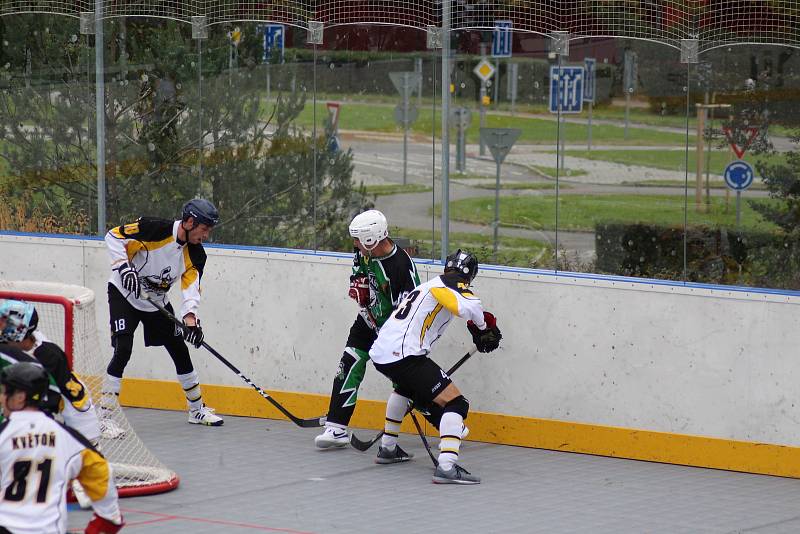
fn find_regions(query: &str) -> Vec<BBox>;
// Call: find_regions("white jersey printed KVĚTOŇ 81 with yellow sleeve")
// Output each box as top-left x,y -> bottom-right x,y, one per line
0,410 -> 121,534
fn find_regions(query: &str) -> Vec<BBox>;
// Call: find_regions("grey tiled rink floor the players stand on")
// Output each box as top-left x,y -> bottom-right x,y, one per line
69,408 -> 800,534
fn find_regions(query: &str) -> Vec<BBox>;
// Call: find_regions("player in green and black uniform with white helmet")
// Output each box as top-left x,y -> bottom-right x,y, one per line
314,210 -> 419,449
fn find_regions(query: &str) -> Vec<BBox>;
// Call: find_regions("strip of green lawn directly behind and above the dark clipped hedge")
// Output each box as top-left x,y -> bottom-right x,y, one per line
436,195 -> 774,231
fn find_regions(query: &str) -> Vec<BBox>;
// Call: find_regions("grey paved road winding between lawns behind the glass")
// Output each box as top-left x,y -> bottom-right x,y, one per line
342,133 -> 766,261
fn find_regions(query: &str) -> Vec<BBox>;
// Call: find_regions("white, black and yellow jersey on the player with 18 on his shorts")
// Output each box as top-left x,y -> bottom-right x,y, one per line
106,217 -> 206,317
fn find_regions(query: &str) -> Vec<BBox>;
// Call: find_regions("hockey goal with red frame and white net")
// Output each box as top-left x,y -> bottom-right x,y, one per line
0,280 -> 179,497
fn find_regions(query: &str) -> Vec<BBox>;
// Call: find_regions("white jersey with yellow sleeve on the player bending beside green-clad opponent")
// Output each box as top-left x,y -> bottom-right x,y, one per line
369,274 -> 486,364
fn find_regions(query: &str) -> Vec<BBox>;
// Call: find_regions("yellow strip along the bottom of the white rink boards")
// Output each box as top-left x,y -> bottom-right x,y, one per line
121,378 -> 800,478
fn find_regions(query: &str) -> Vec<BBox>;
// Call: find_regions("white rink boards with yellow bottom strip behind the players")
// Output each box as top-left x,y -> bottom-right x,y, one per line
0,235 -> 800,482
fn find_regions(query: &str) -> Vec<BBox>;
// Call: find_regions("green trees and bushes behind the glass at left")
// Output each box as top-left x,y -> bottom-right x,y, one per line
0,16 -> 363,253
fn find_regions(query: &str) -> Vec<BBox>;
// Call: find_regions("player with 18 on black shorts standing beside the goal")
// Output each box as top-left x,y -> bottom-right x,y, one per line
100,199 -> 223,426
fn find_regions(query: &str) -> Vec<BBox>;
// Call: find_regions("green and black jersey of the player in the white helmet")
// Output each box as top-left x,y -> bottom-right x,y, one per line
353,245 -> 419,329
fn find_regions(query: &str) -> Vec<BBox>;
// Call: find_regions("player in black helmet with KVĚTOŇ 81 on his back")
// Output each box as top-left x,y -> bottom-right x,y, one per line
0,362 -> 123,534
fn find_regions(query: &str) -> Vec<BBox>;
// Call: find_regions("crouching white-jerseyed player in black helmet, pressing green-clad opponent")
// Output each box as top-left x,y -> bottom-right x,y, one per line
369,249 -> 502,484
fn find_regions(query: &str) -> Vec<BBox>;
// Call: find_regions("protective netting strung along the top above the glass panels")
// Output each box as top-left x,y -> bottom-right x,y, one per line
0,0 -> 800,50
